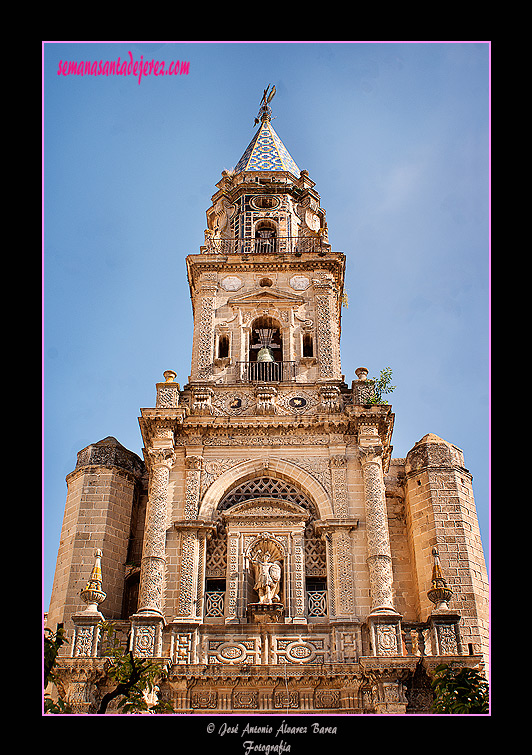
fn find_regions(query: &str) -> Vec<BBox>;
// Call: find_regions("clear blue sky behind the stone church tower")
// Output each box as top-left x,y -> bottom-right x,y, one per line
43,42 -> 490,610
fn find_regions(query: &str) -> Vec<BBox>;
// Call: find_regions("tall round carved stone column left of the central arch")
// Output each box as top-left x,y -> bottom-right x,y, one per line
138,448 -> 175,616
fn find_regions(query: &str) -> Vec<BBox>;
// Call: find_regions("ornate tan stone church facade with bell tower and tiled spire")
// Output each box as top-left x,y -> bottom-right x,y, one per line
50,88 -> 488,714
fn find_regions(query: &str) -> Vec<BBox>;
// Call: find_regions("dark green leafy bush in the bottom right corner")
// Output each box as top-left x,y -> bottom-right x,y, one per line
432,663 -> 489,714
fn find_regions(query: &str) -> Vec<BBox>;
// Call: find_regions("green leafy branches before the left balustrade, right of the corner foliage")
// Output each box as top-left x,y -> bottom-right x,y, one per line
97,622 -> 173,713
